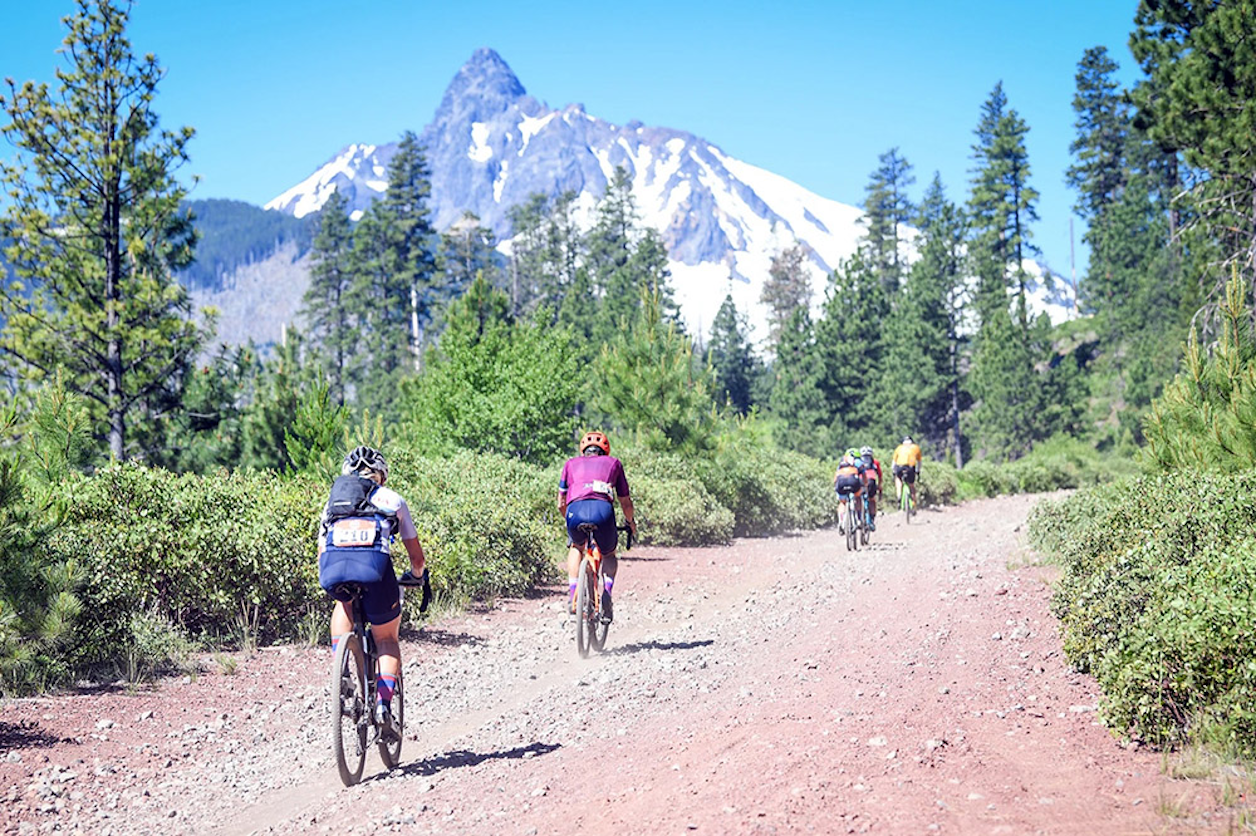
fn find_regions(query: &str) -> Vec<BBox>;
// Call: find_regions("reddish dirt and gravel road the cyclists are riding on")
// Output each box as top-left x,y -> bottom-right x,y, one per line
0,497 -> 1250,836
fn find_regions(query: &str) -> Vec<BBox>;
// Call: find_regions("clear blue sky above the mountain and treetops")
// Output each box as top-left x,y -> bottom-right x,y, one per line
0,0 -> 1138,274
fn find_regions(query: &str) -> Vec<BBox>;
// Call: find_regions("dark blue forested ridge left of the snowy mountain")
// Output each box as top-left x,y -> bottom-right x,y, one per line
178,198 -> 318,290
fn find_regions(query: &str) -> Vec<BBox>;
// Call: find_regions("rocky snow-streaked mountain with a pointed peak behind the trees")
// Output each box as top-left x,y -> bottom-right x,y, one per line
266,49 -> 1070,336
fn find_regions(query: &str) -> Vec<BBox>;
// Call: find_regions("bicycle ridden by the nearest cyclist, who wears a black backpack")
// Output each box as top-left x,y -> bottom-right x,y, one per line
329,571 -> 431,787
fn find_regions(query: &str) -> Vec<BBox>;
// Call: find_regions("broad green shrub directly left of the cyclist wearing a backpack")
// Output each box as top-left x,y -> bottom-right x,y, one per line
45,463 -> 323,662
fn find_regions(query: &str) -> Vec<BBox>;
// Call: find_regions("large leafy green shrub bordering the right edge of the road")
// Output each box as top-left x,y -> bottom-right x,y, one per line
1030,471 -> 1256,754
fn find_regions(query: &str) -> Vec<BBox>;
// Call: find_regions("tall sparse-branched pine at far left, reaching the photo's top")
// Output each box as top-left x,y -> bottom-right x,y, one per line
0,0 -> 203,459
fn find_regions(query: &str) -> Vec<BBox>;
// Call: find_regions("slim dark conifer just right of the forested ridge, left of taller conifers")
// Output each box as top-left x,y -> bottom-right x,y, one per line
301,192 -> 358,405
